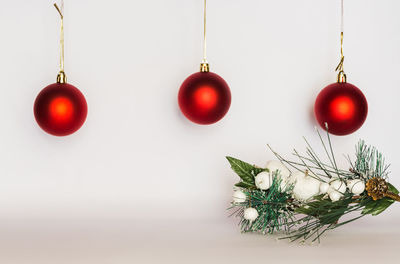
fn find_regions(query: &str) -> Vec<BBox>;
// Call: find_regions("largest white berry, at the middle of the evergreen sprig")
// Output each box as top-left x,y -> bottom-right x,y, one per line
293,172 -> 320,201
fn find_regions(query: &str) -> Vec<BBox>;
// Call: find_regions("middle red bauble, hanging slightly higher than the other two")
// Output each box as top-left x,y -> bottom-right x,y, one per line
178,72 -> 231,125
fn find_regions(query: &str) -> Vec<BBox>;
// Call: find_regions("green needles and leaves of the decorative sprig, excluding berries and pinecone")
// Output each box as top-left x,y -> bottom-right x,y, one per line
227,131 -> 399,241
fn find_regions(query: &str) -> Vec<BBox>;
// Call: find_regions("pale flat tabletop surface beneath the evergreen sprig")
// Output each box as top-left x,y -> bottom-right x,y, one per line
0,214 -> 400,264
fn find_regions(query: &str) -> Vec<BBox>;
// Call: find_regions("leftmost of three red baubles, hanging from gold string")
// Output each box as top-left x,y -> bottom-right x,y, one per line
34,83 -> 87,136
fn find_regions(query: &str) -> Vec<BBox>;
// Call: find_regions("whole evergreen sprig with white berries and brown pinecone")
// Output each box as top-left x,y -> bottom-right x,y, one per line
227,129 -> 400,242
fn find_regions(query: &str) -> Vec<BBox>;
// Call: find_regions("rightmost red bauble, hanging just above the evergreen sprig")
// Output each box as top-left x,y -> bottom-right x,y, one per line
314,83 -> 368,136
